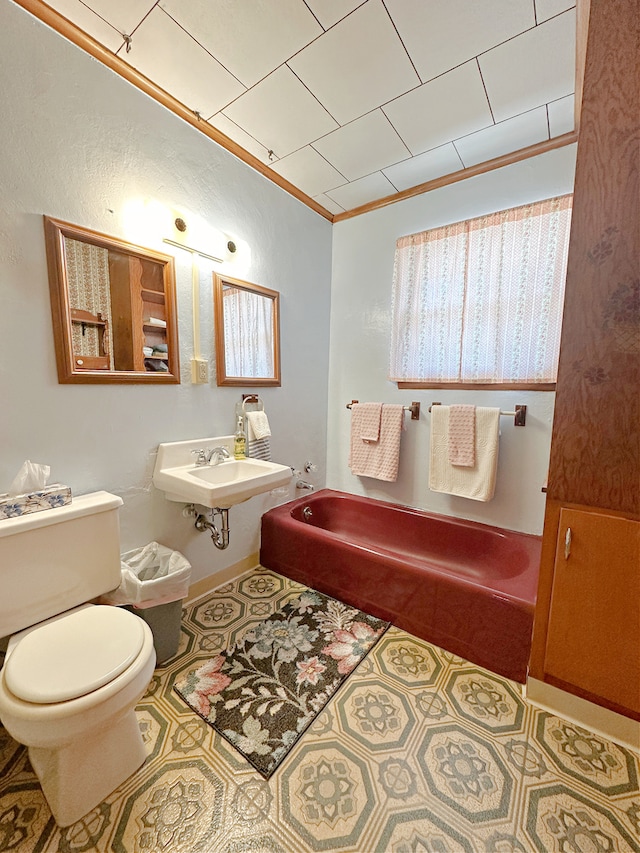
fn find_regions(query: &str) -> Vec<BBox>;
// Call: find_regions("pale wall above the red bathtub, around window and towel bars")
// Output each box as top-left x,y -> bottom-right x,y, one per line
327,146 -> 575,534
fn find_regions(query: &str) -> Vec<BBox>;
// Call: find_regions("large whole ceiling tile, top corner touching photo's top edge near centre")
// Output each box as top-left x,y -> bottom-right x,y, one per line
288,0 -> 420,124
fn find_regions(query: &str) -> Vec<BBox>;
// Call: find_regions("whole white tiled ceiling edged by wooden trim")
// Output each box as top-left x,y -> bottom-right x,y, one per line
33,0 -> 576,214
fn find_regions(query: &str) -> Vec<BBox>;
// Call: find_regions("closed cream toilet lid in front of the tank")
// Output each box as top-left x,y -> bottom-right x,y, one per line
4,605 -> 144,705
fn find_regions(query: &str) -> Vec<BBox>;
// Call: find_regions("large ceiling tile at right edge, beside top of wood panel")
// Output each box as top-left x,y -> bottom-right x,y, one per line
479,10 -> 576,121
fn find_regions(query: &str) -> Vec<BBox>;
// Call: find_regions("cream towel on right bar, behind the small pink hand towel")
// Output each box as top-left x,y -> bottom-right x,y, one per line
429,406 -> 500,501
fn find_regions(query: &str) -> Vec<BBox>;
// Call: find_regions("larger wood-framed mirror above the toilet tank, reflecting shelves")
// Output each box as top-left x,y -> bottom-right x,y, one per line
44,216 -> 180,383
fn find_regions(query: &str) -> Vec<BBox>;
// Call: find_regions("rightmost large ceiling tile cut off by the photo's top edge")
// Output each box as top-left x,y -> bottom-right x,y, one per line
386,0 -> 535,81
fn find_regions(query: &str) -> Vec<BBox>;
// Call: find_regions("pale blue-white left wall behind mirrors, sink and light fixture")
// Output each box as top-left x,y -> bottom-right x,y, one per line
0,0 -> 331,580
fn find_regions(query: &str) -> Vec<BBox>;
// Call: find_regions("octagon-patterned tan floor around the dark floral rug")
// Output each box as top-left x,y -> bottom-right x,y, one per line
0,569 -> 640,853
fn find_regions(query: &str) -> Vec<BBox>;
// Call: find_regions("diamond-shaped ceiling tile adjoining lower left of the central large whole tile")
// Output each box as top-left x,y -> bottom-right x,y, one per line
224,65 -> 337,159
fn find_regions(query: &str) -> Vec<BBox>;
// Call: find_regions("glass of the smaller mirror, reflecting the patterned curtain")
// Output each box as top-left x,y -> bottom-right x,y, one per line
222,287 -> 275,379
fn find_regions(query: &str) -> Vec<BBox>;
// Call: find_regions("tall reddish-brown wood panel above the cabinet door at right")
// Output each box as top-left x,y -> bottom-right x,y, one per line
548,0 -> 640,513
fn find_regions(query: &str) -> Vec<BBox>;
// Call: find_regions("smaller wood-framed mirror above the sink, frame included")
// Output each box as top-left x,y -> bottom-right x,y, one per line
213,274 -> 280,386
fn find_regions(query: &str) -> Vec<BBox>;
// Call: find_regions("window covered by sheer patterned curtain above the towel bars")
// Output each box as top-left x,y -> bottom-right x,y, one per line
389,196 -> 572,388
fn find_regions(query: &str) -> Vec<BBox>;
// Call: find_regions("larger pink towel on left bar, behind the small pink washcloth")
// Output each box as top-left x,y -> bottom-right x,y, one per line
349,403 -> 404,483
